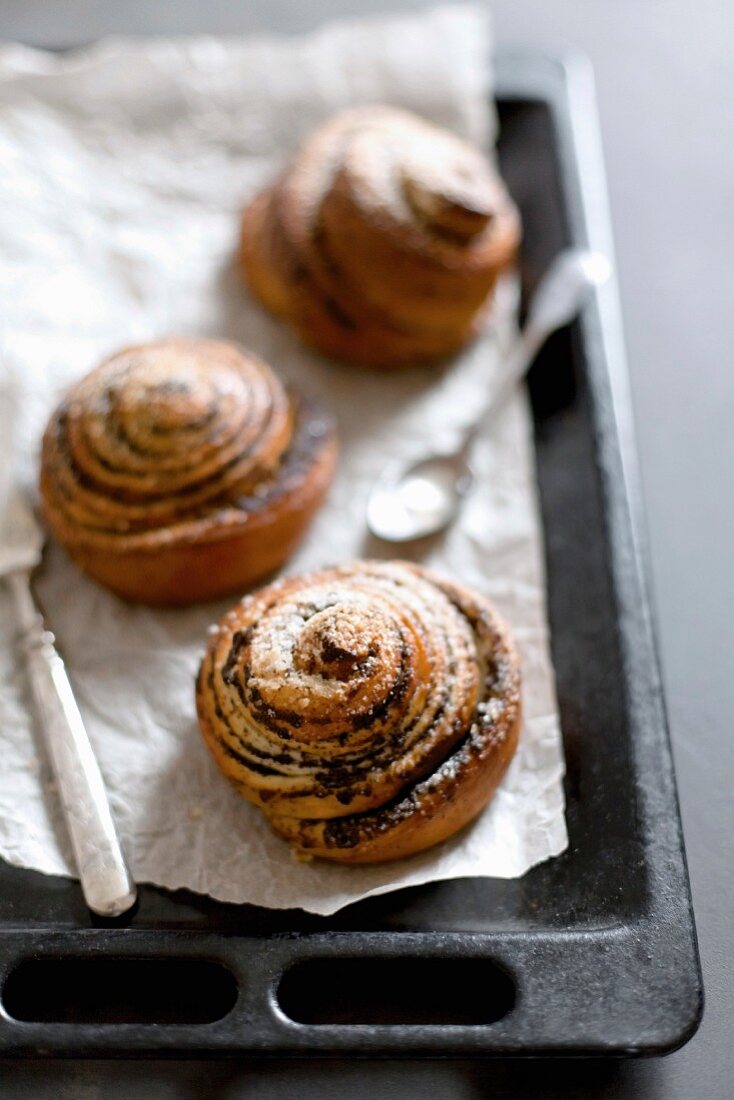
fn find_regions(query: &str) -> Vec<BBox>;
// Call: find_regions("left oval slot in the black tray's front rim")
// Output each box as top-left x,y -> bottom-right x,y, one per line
2,957 -> 238,1025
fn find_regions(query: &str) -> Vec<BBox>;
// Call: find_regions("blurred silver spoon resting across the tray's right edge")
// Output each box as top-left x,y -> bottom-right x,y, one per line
366,249 -> 611,542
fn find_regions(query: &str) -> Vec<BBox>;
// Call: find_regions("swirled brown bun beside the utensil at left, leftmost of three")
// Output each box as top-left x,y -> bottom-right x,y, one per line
41,339 -> 336,605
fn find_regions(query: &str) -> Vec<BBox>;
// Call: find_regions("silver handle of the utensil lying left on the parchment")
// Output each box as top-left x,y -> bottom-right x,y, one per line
8,573 -> 136,917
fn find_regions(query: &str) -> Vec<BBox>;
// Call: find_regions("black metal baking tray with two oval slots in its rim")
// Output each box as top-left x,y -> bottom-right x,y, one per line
0,53 -> 702,1057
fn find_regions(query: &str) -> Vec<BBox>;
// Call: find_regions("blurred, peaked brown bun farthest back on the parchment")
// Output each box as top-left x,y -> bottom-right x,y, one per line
239,107 -> 519,369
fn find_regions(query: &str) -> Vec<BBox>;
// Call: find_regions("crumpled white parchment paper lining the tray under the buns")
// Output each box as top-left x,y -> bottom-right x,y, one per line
0,6 -> 567,913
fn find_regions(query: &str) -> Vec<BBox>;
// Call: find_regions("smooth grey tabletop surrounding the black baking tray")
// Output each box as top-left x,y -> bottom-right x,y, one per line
0,0 -> 734,1100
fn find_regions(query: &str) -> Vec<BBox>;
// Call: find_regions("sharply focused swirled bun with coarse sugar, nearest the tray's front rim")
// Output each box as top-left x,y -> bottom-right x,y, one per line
197,561 -> 521,864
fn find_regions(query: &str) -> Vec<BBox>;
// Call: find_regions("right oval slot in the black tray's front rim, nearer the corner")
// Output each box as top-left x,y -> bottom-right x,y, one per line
277,956 -> 516,1026
